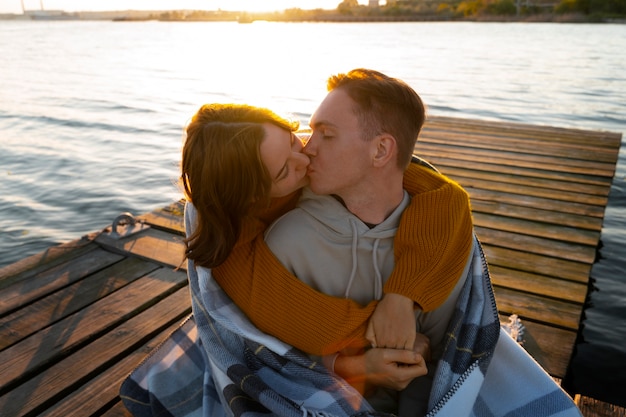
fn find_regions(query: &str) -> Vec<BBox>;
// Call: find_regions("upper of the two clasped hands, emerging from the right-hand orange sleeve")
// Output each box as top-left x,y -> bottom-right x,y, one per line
365,294 -> 415,350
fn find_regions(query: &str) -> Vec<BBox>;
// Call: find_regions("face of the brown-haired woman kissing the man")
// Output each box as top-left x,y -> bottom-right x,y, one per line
261,123 -> 309,197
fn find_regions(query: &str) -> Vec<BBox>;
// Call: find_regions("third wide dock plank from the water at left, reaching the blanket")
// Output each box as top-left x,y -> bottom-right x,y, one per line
0,269 -> 189,394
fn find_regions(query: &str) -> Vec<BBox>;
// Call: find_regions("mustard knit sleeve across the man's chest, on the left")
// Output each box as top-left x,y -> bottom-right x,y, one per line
213,189 -> 377,356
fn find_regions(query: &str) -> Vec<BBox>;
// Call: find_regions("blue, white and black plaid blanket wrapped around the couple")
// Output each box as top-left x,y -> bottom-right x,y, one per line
120,206 -> 581,417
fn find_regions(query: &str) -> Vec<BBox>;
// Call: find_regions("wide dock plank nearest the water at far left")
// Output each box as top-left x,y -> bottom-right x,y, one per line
0,249 -> 122,315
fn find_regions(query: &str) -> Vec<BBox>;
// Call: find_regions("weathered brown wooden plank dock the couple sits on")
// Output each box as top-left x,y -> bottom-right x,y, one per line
0,117 -> 626,417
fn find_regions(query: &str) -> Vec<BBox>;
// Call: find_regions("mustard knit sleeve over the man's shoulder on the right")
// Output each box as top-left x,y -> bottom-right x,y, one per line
384,164 -> 474,311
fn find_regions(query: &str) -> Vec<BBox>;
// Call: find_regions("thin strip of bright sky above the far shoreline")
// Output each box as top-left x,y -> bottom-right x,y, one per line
0,0 -> 356,13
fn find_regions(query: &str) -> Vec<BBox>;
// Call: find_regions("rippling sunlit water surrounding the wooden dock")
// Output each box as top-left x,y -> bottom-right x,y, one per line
0,21 -> 626,406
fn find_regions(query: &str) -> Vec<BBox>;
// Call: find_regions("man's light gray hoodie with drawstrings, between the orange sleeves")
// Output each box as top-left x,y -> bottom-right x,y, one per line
265,188 -> 411,304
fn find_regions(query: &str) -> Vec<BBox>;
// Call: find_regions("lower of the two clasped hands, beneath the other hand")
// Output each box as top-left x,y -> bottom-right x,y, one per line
335,348 -> 428,394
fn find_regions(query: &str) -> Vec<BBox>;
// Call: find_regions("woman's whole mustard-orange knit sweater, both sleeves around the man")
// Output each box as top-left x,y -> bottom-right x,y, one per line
213,164 -> 473,355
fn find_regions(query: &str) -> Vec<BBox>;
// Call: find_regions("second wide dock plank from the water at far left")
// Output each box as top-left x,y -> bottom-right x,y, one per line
0,252 -> 158,350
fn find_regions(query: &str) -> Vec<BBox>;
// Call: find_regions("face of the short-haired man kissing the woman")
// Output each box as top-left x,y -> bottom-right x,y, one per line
304,89 -> 373,196
